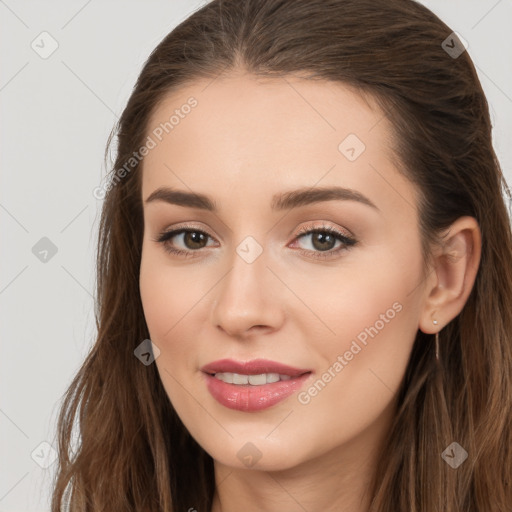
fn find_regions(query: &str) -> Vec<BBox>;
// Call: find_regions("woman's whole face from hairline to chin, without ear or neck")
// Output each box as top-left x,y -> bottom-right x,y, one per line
140,74 -> 425,470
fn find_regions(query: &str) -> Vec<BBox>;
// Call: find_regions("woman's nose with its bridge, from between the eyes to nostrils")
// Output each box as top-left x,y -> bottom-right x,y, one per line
213,235 -> 282,334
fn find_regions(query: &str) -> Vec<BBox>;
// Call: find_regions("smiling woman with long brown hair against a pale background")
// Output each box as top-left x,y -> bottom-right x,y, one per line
52,0 -> 512,512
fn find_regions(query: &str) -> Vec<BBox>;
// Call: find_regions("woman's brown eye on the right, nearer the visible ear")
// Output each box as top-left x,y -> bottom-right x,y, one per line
288,225 -> 357,259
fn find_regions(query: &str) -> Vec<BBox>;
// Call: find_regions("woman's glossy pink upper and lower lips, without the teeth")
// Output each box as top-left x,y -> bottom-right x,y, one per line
201,359 -> 312,412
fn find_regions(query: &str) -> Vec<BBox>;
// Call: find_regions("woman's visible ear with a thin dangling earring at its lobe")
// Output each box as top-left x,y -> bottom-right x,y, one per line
418,217 -> 482,334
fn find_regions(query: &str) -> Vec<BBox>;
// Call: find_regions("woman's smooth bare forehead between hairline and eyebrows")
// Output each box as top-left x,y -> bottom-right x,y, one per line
142,74 -> 408,214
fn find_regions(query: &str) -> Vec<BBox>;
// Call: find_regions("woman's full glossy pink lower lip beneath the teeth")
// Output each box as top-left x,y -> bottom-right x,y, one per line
204,373 -> 311,412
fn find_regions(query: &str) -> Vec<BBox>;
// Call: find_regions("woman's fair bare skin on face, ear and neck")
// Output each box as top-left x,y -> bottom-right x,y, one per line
140,71 -> 481,512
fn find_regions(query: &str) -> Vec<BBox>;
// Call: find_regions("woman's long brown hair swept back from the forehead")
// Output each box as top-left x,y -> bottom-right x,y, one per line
52,0 -> 512,512
